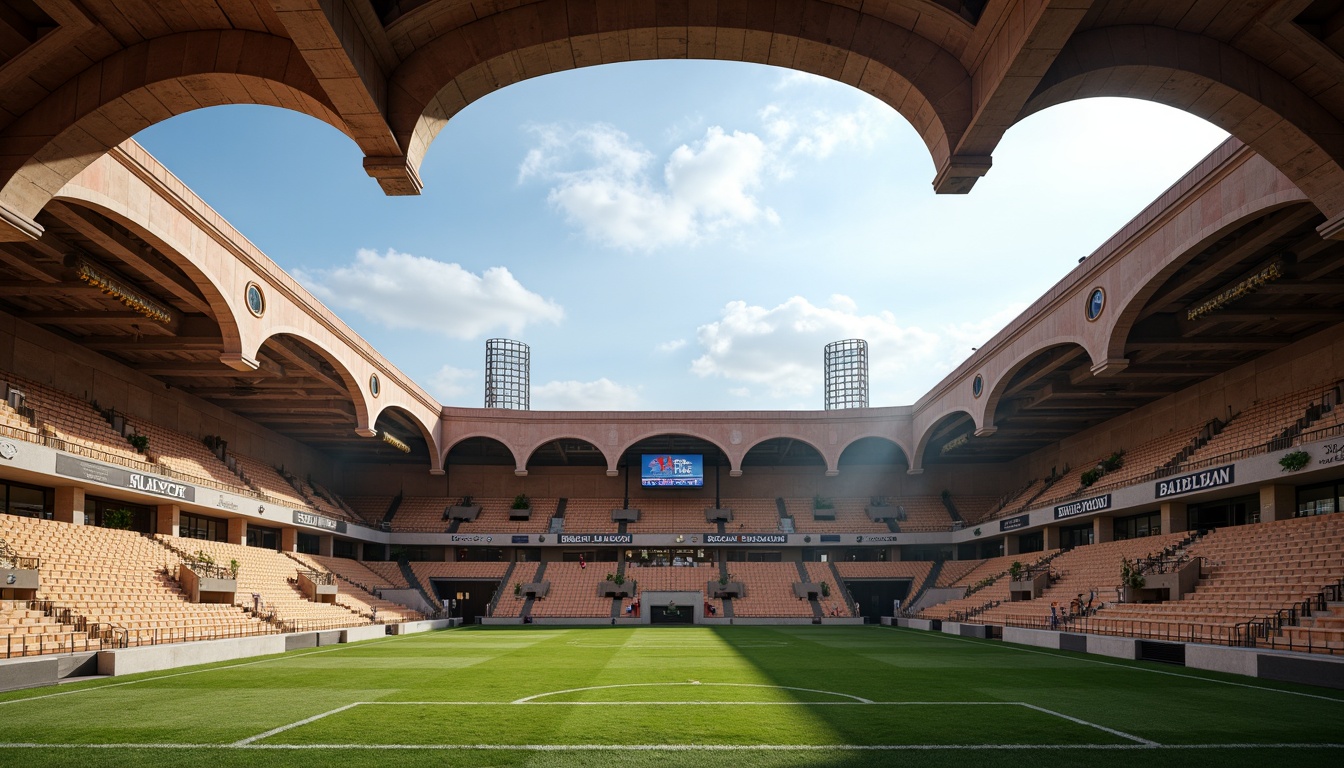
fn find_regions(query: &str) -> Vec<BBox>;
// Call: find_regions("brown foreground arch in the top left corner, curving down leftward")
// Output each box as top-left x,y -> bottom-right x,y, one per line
0,30 -> 349,237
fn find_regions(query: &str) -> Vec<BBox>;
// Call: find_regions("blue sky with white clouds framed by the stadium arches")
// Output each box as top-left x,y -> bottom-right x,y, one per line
137,62 -> 1226,410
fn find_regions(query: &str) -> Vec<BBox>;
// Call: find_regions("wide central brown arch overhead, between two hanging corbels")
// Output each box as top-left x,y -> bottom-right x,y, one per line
387,0 -> 973,193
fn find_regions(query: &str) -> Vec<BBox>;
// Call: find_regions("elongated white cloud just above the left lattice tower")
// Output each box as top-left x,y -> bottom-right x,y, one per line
294,249 -> 564,340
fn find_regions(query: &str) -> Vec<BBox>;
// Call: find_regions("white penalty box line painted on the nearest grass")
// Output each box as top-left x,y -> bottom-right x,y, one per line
227,699 -> 1163,749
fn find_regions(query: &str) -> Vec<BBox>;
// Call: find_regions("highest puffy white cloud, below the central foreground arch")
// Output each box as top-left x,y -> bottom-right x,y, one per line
519,124 -> 778,250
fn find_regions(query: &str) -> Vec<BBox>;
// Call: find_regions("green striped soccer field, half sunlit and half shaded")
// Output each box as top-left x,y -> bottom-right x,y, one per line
0,625 -> 1344,768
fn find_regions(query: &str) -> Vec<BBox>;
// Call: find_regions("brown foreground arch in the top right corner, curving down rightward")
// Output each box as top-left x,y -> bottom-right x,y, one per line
1019,26 -> 1344,229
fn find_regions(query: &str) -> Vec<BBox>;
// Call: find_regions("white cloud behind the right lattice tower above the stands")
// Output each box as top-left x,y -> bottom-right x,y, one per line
691,295 -> 1020,408
